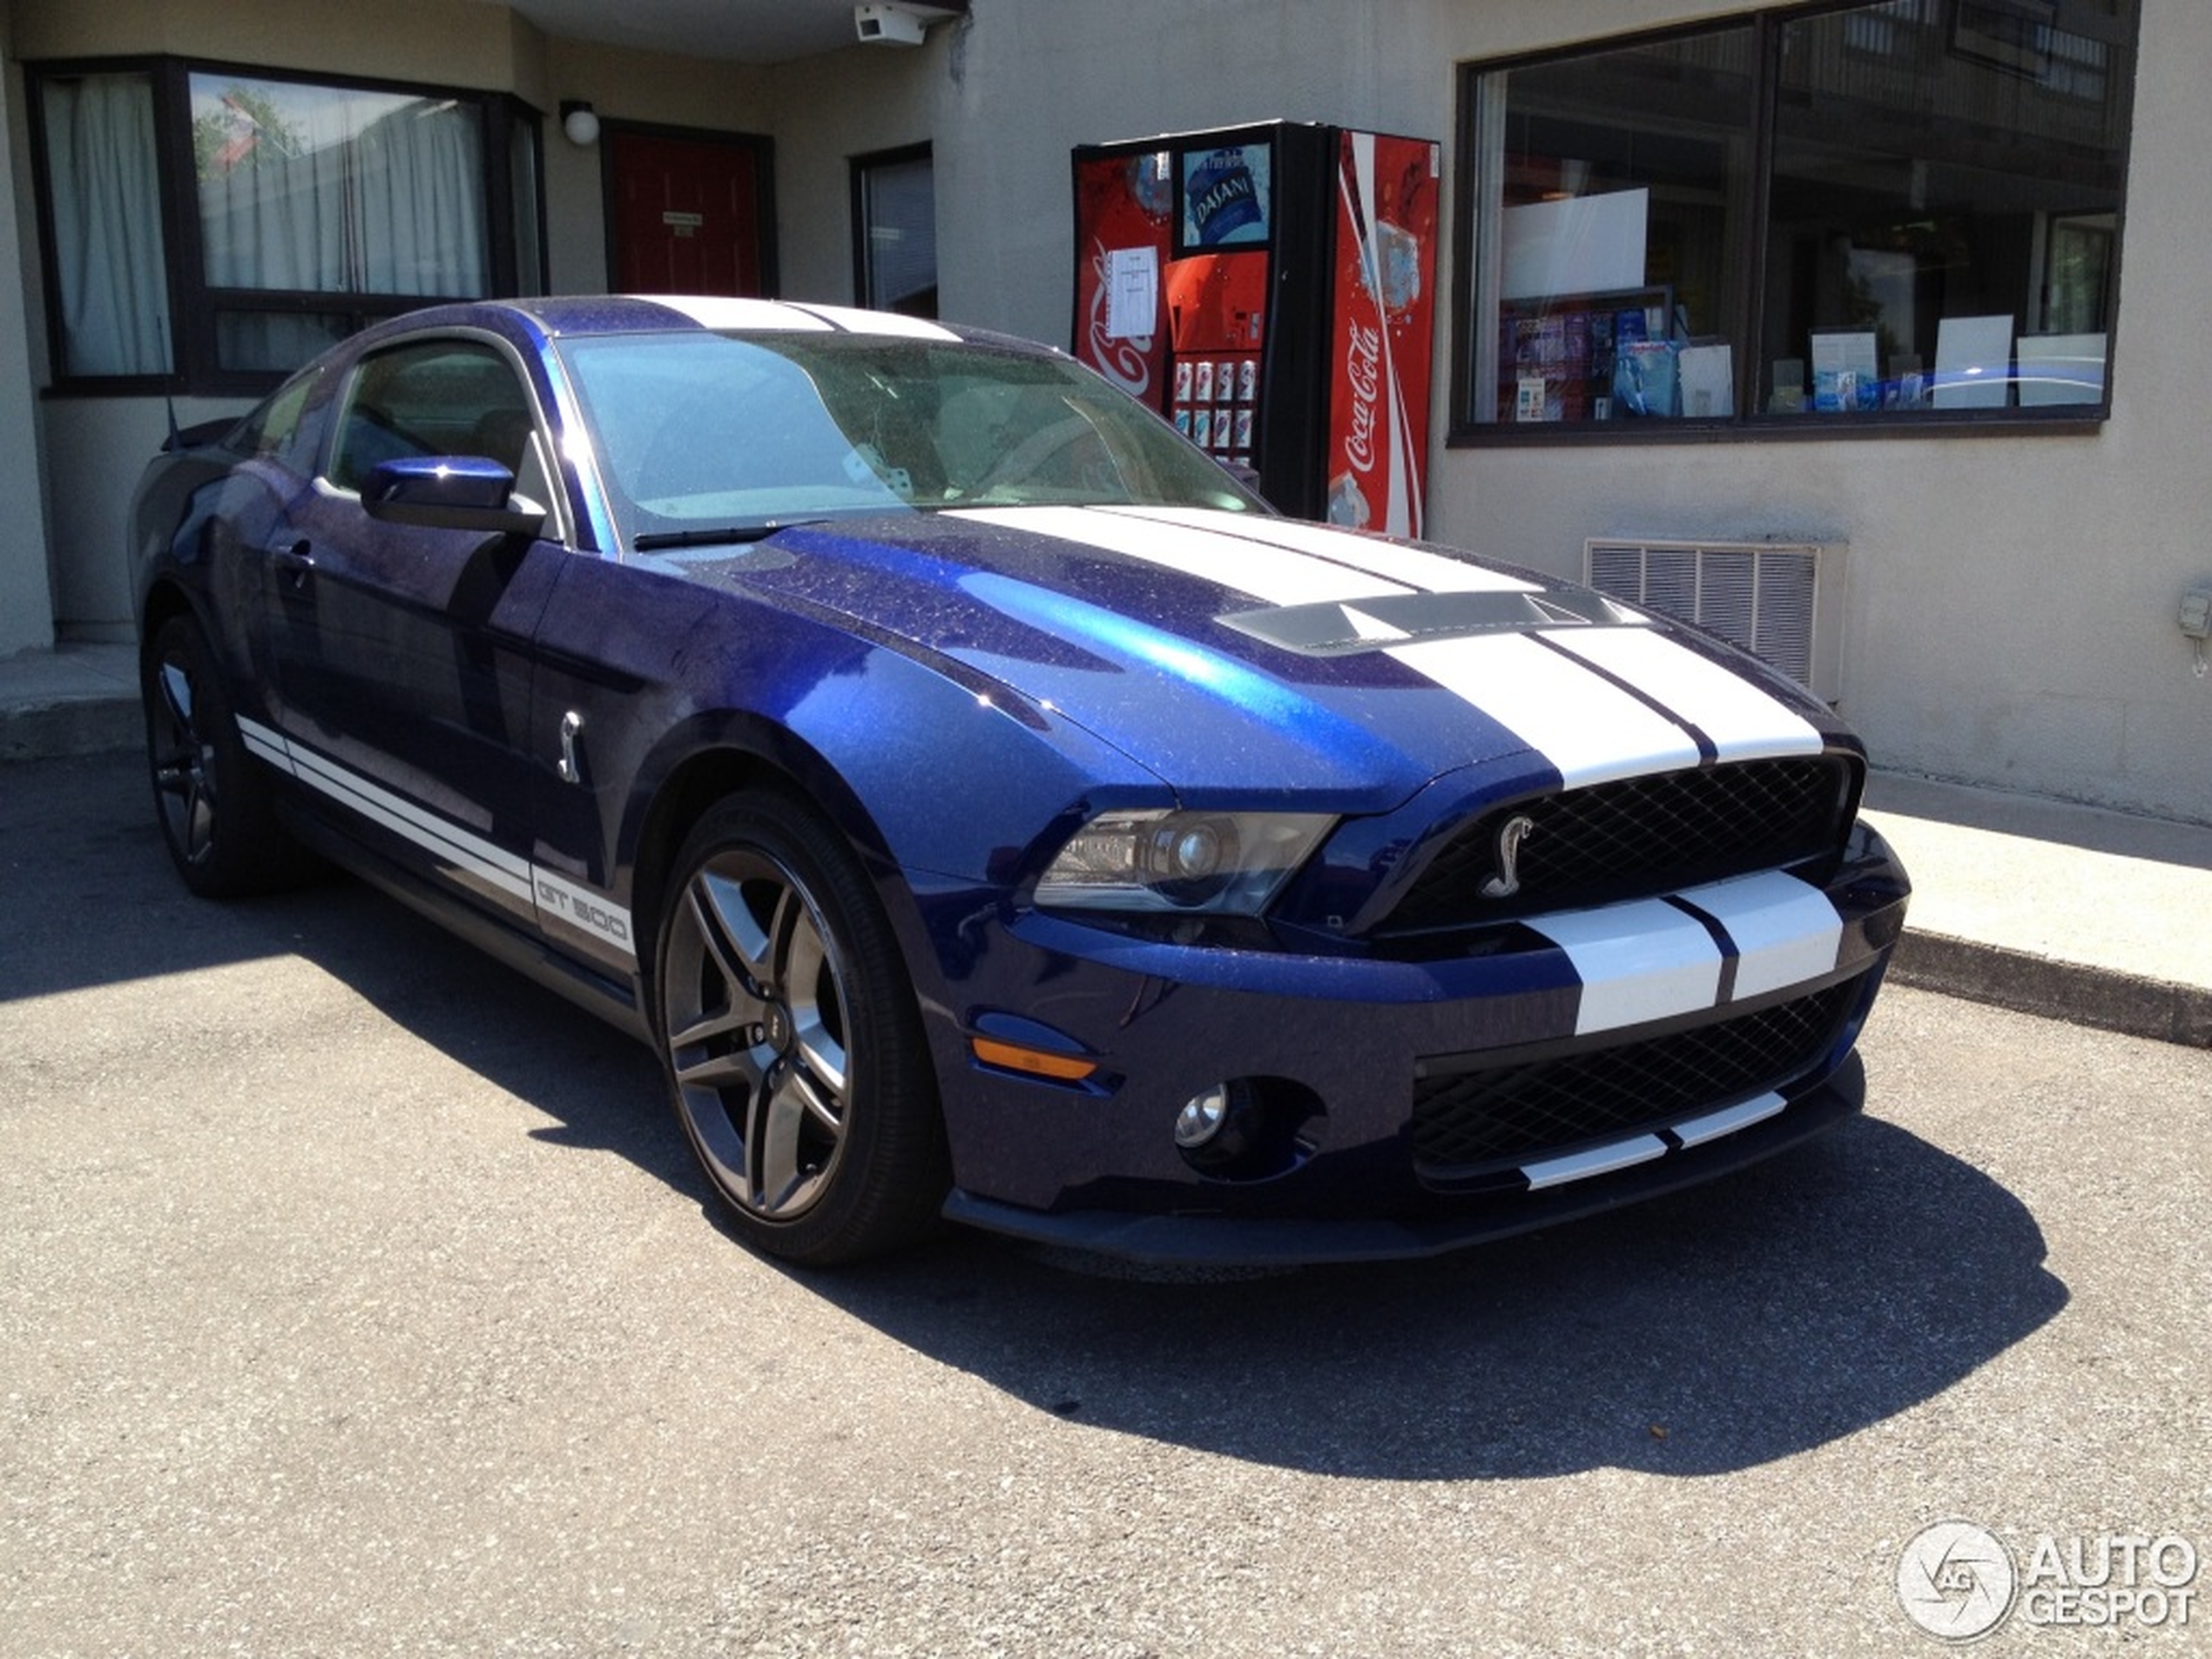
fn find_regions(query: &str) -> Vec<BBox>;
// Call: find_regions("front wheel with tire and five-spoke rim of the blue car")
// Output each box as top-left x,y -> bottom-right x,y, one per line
655,790 -> 949,1267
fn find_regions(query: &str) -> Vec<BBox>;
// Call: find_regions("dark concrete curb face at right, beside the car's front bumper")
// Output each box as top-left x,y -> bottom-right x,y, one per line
1889,922 -> 2212,1049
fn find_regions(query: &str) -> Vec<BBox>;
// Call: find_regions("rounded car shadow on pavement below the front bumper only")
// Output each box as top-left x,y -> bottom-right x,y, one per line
814,1119 -> 2066,1480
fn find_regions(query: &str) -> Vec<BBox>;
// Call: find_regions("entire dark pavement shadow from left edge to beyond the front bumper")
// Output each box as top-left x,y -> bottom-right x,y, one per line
0,774 -> 2066,1480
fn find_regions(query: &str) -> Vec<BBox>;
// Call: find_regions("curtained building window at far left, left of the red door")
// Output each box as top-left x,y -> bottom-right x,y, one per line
33,62 -> 542,392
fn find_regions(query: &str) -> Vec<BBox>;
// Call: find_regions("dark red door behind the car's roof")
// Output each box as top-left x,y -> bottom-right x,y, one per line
609,131 -> 767,296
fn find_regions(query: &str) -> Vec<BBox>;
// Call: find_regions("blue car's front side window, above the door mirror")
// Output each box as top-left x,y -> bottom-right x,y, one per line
329,341 -> 550,502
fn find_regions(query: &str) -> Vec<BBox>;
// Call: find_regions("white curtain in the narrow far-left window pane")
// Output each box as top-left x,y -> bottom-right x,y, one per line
44,75 -> 171,376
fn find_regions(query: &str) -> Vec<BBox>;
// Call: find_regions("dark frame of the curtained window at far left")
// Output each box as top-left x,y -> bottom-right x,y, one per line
24,56 -> 549,396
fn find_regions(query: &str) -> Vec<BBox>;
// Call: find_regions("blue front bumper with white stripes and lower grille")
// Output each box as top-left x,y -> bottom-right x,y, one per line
907,827 -> 1909,1263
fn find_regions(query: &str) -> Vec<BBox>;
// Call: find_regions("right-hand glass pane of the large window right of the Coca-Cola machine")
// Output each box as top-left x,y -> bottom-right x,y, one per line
1765,0 -> 2123,414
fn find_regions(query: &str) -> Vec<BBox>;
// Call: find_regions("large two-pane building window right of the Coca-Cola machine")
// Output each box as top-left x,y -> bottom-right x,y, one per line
1453,0 -> 2137,438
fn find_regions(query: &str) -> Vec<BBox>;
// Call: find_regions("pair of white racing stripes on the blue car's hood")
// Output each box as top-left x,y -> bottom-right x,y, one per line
949,507 -> 1820,790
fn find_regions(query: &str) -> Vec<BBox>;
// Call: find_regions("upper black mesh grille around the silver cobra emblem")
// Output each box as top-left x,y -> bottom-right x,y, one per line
1378,754 -> 1854,935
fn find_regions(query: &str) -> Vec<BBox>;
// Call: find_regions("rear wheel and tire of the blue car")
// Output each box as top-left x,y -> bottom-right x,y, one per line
139,615 -> 312,898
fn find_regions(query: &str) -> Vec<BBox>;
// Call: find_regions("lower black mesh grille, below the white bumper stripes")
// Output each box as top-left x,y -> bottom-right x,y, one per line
1413,978 -> 1860,1184
